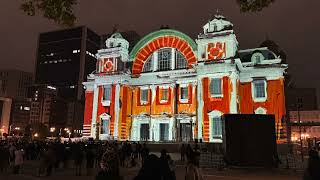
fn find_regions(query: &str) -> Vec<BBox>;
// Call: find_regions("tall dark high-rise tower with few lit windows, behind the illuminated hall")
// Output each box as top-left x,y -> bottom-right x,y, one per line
35,26 -> 100,100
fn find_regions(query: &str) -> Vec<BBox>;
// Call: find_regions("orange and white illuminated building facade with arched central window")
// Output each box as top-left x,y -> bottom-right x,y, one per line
83,15 -> 287,142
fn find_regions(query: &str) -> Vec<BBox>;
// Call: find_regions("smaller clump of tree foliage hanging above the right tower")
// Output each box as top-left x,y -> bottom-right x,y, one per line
237,0 -> 275,13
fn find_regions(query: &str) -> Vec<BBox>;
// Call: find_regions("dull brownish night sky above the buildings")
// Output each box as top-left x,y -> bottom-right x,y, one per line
0,0 -> 320,98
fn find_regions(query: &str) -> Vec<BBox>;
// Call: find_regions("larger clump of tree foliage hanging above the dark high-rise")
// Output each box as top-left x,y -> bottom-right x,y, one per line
21,0 -> 77,26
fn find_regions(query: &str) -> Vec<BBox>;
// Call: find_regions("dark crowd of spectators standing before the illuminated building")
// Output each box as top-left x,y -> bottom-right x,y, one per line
0,139 -> 202,180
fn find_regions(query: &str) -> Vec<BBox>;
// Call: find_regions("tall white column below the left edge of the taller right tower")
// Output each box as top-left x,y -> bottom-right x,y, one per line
197,78 -> 203,139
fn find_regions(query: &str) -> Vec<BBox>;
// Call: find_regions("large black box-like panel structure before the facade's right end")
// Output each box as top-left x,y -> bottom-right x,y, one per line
223,114 -> 276,167
